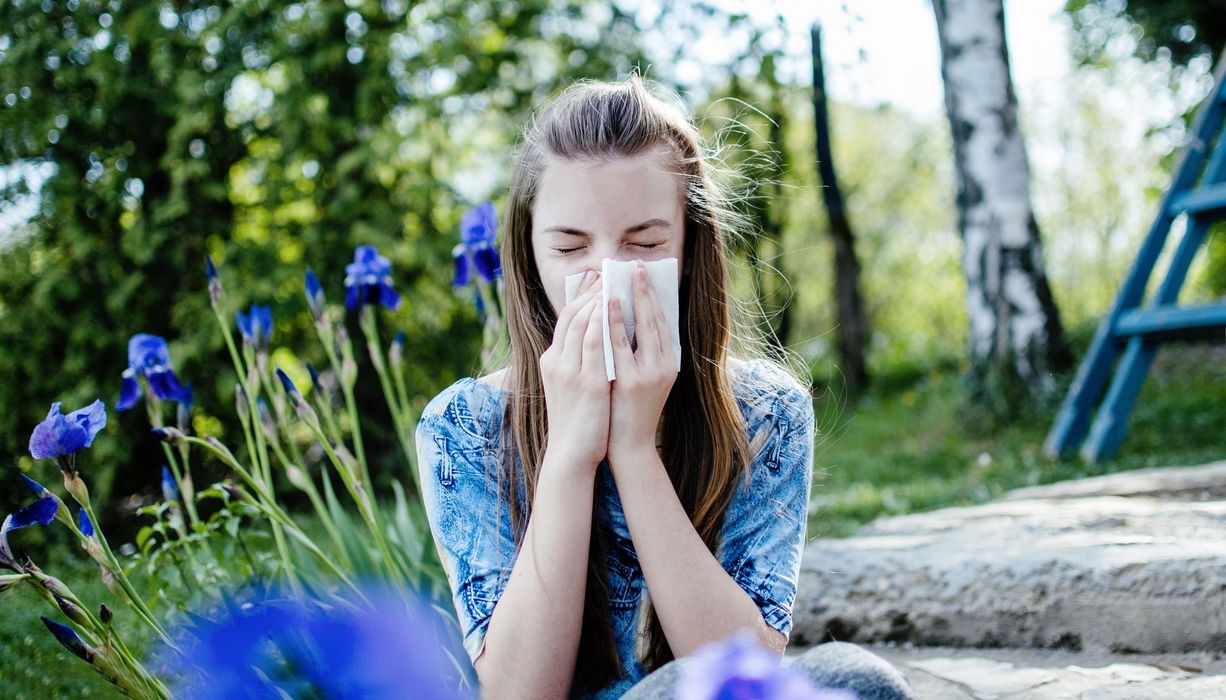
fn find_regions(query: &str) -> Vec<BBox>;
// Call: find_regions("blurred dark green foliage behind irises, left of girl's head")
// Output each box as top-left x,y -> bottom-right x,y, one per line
0,0 -> 671,524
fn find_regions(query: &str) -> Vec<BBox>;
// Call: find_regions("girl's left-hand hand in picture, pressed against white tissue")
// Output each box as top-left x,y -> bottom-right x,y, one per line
541,272 -> 610,474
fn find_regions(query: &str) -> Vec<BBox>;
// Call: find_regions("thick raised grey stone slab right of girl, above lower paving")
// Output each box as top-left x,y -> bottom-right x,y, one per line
792,495 -> 1226,652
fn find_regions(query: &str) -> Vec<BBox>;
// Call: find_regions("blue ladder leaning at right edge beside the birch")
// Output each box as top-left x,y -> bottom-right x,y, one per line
1043,53 -> 1226,462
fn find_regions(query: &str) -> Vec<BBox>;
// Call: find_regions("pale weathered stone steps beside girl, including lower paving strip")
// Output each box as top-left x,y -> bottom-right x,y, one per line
788,462 -> 1226,700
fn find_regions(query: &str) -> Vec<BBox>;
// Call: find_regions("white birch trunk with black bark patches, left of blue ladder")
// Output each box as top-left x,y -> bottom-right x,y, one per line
933,0 -> 1070,413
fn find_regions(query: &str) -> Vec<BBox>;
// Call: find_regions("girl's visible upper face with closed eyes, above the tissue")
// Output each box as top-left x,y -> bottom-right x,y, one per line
532,151 -> 685,313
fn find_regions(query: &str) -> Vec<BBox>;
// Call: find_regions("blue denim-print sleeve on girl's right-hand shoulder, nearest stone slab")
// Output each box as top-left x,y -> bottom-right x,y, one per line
718,382 -> 814,636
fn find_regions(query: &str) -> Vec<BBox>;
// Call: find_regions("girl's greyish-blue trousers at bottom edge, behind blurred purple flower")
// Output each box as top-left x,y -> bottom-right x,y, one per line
622,641 -> 913,700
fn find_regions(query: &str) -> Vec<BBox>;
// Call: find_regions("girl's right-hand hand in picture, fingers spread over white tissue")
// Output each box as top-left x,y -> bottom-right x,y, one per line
608,264 -> 677,467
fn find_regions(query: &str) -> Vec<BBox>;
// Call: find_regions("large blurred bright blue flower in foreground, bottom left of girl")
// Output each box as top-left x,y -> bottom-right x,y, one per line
158,591 -> 476,700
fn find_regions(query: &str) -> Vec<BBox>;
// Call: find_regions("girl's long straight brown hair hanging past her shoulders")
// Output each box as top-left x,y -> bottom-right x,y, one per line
487,75 -> 794,689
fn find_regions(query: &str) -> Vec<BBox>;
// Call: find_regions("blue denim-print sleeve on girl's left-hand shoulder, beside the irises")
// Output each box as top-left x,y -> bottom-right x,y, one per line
417,385 -> 515,661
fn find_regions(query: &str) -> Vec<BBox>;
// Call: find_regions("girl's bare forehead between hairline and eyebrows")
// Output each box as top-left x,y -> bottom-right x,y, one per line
532,151 -> 683,232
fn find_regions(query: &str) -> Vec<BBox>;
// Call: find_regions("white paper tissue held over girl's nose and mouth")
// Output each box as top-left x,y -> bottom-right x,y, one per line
565,257 -> 682,381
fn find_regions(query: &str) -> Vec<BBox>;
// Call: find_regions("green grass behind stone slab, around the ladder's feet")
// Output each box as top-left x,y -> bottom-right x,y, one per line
809,346 -> 1226,538
